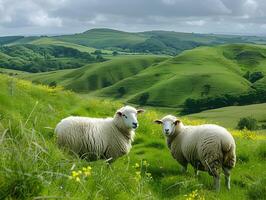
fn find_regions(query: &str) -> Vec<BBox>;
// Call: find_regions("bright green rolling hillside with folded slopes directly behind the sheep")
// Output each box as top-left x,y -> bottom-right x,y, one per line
22,44 -> 266,108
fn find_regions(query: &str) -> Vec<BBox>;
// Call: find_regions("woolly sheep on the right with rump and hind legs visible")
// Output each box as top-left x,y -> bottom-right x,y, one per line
155,115 -> 236,191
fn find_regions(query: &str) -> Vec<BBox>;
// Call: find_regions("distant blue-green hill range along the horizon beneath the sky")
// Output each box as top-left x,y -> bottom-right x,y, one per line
3,28 -> 266,55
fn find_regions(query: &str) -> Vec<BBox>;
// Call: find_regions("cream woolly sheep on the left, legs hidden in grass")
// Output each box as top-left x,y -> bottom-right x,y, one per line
55,106 -> 144,162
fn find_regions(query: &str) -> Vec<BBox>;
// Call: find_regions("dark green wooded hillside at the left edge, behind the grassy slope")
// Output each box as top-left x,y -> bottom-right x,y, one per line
0,44 -> 104,72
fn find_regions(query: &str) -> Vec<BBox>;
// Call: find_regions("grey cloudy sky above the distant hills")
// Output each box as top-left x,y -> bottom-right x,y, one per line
0,0 -> 266,36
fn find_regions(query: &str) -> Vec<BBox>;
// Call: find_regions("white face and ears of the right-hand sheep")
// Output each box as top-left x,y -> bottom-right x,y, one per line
154,115 -> 180,137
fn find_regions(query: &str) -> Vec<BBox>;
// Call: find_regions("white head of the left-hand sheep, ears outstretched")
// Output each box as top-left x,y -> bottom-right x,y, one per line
117,106 -> 144,129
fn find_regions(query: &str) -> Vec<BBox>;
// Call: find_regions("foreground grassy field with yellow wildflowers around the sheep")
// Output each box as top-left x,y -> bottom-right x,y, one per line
0,75 -> 266,200
